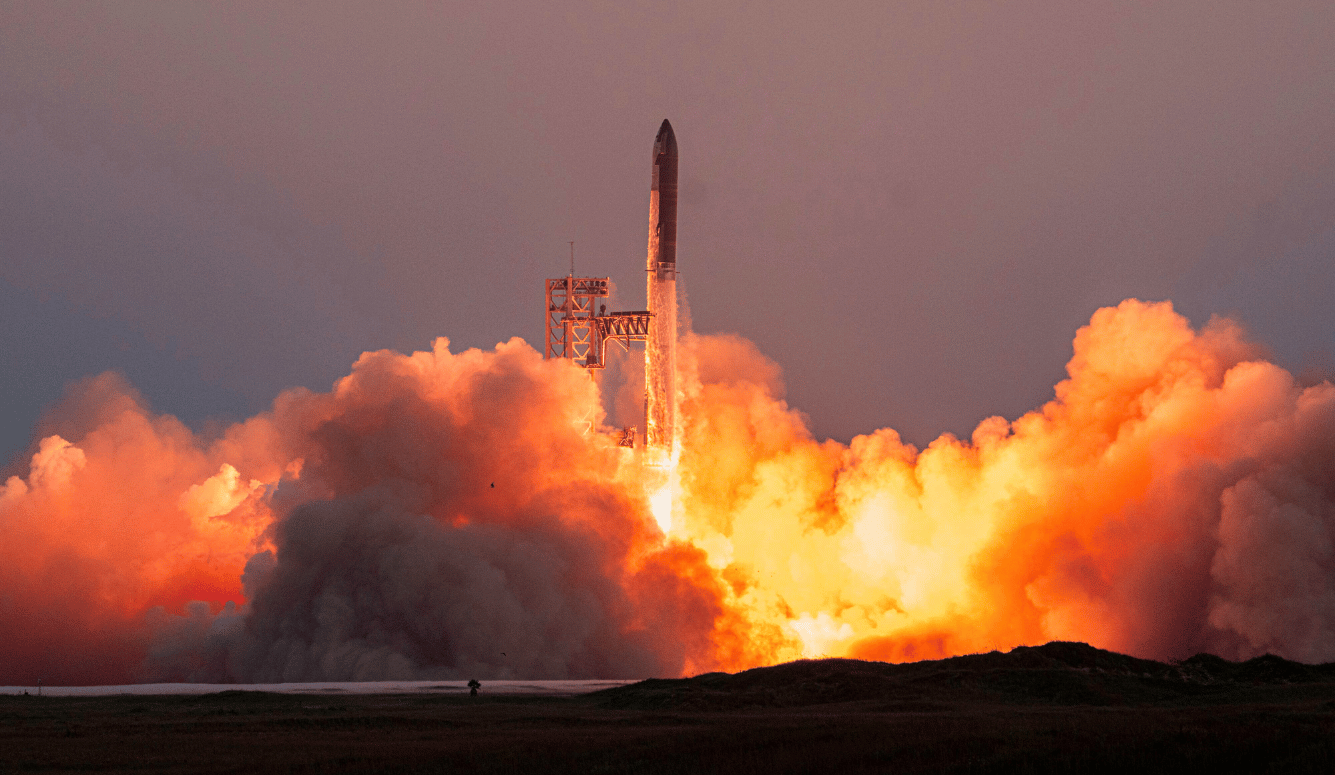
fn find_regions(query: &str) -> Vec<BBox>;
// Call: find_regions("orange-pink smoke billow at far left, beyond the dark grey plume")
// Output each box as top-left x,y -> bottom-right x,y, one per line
0,373 -> 276,683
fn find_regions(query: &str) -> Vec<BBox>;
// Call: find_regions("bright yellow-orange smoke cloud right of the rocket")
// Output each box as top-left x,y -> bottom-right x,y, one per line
681,300 -> 1335,662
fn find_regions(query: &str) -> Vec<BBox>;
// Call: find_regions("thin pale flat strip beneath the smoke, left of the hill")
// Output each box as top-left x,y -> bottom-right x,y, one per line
0,680 -> 635,696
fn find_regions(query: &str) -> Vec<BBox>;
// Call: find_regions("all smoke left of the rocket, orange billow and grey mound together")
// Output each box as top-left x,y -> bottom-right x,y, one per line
0,340 -> 756,682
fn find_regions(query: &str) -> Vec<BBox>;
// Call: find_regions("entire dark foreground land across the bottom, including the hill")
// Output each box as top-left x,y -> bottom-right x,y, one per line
0,643 -> 1335,775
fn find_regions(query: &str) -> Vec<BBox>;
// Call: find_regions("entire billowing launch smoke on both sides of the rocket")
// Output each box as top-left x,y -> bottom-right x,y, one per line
0,300 -> 1335,683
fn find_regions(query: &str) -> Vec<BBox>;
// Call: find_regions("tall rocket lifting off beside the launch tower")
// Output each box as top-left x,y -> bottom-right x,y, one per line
645,119 -> 677,456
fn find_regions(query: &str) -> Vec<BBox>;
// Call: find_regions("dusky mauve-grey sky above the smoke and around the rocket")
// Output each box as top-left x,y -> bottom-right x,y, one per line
0,1 -> 1335,468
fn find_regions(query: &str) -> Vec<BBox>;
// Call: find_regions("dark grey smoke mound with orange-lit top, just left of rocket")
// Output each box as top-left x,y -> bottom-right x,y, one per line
146,344 -> 721,682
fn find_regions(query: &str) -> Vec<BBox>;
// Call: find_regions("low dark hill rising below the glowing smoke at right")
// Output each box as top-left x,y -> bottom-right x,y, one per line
590,642 -> 1335,711
